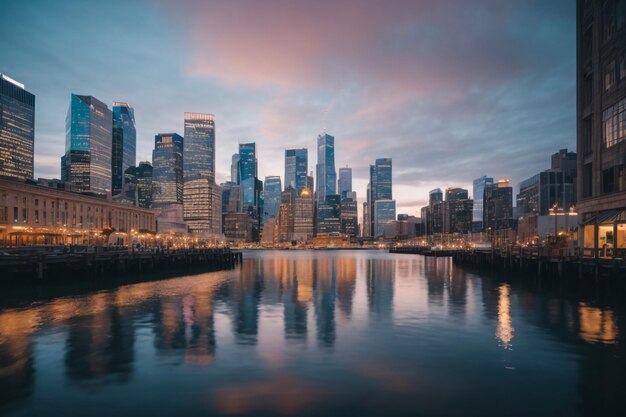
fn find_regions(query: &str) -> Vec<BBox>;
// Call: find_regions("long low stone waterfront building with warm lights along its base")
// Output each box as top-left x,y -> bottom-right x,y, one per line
0,180 -> 157,246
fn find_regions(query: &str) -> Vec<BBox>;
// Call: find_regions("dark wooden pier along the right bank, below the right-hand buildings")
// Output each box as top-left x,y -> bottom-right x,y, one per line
389,245 -> 626,279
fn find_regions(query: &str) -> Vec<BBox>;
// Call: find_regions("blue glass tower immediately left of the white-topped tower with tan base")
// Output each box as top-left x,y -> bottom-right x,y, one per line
152,133 -> 183,207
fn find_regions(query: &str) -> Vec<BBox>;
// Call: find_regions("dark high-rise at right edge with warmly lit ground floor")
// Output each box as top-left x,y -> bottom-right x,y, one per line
576,0 -> 626,258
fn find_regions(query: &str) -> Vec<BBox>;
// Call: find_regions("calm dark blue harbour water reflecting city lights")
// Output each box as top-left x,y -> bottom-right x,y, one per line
0,251 -> 626,416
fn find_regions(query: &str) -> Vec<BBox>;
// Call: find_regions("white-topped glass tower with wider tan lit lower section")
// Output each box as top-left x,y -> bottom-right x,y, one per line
183,112 -> 222,236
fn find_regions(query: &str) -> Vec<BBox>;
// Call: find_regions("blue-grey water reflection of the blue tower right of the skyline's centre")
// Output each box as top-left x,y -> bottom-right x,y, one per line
365,259 -> 395,319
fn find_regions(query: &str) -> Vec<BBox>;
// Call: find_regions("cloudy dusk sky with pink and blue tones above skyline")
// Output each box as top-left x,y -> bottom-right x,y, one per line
0,0 -> 576,216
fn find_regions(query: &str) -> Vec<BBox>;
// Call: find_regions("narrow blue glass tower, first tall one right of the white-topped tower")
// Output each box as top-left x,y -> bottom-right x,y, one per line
239,142 -> 263,241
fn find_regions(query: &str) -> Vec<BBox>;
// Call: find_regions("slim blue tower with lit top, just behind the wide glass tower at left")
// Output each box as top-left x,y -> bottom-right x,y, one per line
111,101 -> 137,195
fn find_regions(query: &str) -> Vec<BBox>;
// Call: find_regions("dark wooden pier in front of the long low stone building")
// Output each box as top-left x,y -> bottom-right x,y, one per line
0,248 -> 242,284
